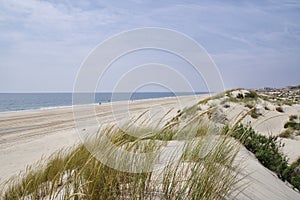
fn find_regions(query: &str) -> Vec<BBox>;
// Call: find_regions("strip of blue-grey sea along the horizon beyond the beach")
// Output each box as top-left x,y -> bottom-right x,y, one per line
0,92 -> 206,112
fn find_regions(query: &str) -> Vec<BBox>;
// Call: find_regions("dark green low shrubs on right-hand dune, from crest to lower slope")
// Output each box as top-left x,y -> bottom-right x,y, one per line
192,89 -> 300,190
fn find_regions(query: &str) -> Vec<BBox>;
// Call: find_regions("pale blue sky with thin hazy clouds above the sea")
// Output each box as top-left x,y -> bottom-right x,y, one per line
0,0 -> 300,92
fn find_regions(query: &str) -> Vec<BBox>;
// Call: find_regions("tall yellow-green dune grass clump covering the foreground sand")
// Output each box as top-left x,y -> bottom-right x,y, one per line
1,113 -> 238,200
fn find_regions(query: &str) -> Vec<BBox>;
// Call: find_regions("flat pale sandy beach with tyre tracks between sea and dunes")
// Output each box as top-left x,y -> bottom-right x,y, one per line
0,95 -> 209,182
